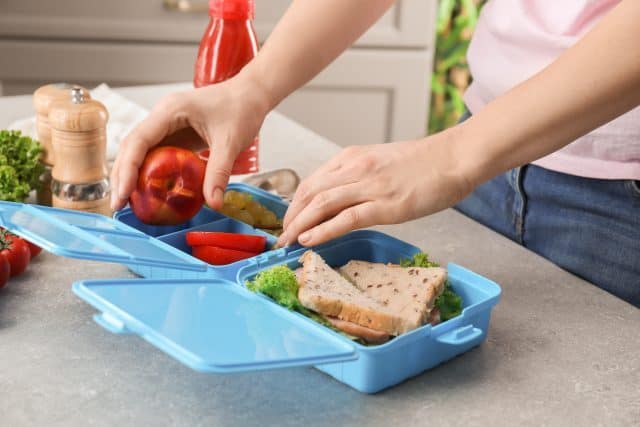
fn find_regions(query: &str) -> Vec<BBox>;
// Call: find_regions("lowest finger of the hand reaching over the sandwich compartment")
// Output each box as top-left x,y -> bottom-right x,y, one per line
298,202 -> 381,246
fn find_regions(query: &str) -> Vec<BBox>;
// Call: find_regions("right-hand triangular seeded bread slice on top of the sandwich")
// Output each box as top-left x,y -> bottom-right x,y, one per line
339,261 -> 447,332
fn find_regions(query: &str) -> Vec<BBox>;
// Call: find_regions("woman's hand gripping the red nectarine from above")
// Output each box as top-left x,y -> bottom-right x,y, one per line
111,75 -> 270,214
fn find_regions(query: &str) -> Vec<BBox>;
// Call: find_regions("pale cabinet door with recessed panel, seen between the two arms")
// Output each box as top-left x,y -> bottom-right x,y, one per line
278,49 -> 431,146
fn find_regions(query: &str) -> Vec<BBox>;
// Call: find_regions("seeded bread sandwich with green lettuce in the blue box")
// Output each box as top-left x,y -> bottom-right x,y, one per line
247,250 -> 461,345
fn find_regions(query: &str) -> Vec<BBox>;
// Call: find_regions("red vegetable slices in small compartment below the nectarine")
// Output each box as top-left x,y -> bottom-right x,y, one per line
185,231 -> 267,265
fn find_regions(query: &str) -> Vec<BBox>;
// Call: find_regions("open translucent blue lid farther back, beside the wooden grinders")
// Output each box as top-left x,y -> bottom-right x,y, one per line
0,201 -> 207,271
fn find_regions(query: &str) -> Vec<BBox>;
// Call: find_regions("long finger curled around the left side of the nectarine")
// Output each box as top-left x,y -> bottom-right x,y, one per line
111,94 -> 188,210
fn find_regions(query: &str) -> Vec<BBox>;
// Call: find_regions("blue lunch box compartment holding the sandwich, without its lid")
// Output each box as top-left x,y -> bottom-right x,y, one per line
237,230 -> 500,393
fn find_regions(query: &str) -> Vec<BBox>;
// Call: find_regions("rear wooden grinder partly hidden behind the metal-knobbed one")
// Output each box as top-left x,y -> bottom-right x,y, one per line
33,83 -> 89,206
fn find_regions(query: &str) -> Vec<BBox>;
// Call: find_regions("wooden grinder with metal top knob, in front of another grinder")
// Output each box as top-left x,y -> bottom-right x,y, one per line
49,86 -> 111,215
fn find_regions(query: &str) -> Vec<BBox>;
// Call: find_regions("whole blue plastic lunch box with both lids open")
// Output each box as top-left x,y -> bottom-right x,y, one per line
0,184 -> 500,393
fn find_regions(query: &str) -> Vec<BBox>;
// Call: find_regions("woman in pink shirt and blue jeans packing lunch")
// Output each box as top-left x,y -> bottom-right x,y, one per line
112,0 -> 640,306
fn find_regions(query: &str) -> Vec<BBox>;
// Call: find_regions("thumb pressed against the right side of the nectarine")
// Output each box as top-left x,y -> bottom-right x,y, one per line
202,142 -> 239,210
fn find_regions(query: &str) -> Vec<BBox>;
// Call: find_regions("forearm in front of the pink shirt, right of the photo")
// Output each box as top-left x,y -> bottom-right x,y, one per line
450,0 -> 640,186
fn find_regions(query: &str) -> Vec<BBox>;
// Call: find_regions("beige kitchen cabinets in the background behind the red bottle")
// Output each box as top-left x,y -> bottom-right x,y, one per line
0,0 -> 436,145
